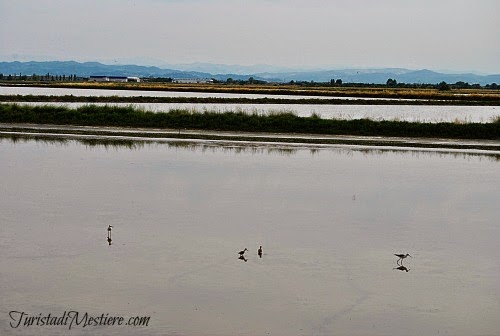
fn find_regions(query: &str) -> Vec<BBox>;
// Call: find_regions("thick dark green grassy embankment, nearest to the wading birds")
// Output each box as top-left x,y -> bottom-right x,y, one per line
0,104 -> 500,140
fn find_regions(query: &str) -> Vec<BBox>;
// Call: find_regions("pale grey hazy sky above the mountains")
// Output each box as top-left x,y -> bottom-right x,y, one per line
0,0 -> 500,73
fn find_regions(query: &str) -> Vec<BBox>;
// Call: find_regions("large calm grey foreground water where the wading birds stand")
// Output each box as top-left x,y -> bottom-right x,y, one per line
0,139 -> 500,335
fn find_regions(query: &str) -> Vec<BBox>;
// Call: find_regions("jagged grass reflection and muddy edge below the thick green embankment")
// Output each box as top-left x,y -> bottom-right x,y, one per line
0,131 -> 500,161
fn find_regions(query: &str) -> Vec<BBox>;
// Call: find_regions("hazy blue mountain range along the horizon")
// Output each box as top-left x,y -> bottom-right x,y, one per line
0,61 -> 500,85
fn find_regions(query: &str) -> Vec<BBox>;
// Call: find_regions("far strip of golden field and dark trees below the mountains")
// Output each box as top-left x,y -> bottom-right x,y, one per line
0,81 -> 500,105
